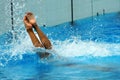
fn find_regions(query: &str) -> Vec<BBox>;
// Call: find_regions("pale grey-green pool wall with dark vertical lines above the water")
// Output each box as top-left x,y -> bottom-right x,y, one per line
0,0 -> 120,34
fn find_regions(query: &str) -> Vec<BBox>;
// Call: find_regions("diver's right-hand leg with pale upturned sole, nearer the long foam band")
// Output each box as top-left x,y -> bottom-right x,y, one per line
27,12 -> 52,49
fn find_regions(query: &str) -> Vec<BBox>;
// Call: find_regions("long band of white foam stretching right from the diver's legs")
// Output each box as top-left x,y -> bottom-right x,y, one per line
51,40 -> 120,57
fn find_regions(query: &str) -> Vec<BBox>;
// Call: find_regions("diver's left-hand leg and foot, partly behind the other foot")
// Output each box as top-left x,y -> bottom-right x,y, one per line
23,15 -> 43,47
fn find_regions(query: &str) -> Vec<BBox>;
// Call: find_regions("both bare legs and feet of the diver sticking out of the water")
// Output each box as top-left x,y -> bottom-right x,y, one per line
23,12 -> 52,49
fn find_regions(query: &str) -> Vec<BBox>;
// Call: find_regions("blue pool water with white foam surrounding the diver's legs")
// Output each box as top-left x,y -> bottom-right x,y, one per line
0,13 -> 120,80
